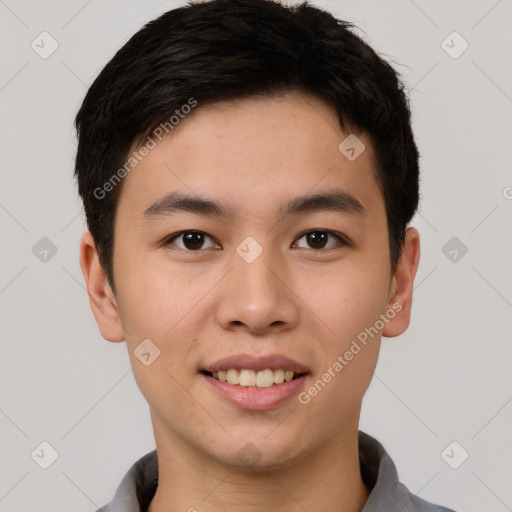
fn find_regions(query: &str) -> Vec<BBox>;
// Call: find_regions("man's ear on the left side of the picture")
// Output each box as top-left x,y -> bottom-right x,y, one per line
80,231 -> 124,342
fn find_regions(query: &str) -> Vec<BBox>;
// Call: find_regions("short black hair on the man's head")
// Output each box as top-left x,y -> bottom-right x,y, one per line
75,0 -> 419,292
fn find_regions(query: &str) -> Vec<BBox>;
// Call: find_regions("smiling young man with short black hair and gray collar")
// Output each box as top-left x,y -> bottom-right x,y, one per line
75,0 -> 456,512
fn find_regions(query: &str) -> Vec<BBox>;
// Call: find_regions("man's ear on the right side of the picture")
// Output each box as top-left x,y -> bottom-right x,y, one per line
382,228 -> 420,338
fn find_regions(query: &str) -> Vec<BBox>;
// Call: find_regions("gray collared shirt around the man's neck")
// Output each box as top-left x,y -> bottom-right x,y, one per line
97,432 -> 454,512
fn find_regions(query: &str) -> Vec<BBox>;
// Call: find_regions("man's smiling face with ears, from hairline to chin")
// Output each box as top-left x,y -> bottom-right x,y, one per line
82,93 -> 417,469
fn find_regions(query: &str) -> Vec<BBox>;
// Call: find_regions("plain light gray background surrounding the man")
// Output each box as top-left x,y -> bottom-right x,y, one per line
0,0 -> 512,512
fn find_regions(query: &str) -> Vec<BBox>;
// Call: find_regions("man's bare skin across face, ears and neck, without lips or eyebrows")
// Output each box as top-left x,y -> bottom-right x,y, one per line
80,92 -> 420,512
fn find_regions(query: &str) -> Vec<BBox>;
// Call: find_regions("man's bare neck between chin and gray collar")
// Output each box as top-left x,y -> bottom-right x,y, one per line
148,412 -> 369,512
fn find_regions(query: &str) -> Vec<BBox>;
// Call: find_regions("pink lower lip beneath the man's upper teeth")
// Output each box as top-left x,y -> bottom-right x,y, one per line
201,373 -> 307,411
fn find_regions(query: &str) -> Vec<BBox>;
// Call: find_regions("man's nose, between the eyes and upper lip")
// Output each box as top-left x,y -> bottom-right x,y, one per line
216,245 -> 299,335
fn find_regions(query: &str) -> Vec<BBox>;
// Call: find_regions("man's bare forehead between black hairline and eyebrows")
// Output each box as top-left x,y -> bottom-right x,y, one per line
114,92 -> 382,222
